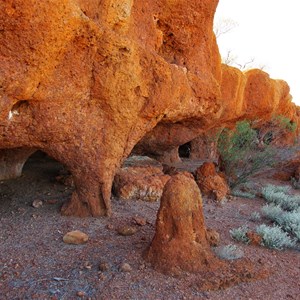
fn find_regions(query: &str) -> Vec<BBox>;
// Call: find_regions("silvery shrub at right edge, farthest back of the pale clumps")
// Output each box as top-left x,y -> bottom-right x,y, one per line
262,185 -> 300,211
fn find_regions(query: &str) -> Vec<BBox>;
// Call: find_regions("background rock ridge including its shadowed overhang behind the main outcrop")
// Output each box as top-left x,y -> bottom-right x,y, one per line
135,64 -> 299,163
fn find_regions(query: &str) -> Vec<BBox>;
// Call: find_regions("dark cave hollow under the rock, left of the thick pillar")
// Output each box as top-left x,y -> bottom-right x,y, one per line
0,149 -> 74,216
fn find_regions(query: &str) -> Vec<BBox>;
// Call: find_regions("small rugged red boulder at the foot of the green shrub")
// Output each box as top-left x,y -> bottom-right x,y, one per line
195,162 -> 229,201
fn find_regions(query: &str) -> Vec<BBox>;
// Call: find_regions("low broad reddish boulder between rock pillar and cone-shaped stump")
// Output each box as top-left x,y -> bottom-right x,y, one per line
113,156 -> 170,202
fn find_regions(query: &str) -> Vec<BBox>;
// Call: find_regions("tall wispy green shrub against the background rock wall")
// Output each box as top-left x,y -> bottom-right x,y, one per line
217,121 -> 275,188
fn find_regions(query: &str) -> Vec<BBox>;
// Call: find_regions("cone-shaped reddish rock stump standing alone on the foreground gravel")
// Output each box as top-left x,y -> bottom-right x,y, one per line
146,173 -> 219,274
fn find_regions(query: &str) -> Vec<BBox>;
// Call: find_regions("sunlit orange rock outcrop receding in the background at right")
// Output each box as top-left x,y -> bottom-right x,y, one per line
189,65 -> 300,159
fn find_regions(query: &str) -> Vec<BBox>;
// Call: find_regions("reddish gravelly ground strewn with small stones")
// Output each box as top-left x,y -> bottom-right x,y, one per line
0,155 -> 300,300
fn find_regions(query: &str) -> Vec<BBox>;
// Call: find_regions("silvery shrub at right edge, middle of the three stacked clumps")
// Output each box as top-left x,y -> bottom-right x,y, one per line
262,205 -> 300,241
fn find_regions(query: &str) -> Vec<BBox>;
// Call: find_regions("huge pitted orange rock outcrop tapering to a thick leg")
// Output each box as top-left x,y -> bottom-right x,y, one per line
0,0 -> 221,216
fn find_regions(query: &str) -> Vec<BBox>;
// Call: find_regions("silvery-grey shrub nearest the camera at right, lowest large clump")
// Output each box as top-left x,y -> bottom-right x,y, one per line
256,224 -> 296,250
